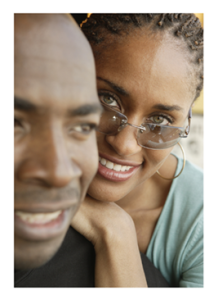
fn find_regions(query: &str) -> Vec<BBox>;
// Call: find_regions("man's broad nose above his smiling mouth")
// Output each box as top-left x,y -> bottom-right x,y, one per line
17,126 -> 82,187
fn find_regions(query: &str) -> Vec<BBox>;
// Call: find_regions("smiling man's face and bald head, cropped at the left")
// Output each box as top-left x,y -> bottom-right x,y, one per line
14,15 -> 101,269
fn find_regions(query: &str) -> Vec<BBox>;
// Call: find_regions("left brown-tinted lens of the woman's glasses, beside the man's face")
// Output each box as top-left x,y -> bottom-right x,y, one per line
97,106 -> 125,135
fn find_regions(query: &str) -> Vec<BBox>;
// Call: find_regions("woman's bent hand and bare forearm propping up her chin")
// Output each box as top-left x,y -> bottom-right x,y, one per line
71,196 -> 147,287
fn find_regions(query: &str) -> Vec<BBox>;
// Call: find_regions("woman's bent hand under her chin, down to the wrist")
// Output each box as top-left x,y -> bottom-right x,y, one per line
71,196 -> 135,247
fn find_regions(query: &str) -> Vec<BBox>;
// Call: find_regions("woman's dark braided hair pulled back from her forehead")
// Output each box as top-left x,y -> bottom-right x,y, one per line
80,14 -> 204,99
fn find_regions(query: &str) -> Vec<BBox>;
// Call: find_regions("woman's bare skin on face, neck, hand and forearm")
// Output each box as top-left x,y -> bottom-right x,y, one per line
72,29 -> 197,287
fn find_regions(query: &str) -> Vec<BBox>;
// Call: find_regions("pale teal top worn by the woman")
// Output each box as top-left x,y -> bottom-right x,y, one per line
146,157 -> 203,287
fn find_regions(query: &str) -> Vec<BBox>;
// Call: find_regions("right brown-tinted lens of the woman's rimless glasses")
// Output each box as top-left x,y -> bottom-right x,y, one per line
138,124 -> 184,149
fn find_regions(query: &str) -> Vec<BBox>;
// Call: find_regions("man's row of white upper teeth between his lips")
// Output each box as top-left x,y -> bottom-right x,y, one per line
15,210 -> 62,224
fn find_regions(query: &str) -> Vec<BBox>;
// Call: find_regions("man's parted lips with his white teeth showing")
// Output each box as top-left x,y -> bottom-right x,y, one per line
14,209 -> 70,241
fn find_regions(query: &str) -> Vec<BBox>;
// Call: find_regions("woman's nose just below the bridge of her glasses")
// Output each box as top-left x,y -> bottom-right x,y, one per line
106,126 -> 142,157
